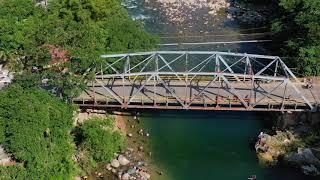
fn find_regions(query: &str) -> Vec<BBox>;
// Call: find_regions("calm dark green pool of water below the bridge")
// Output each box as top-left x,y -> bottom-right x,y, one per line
142,111 -> 307,180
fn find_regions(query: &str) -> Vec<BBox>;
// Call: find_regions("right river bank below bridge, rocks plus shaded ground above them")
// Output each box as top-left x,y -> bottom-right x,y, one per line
255,112 -> 320,177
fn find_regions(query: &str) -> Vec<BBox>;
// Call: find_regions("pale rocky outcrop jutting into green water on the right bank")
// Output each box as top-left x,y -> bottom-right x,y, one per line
255,113 -> 320,176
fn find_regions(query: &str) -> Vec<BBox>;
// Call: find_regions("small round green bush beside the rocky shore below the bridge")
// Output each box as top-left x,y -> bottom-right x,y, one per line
80,117 -> 125,171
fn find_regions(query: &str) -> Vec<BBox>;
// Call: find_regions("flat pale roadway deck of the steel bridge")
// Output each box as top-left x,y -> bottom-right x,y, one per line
74,79 -> 320,111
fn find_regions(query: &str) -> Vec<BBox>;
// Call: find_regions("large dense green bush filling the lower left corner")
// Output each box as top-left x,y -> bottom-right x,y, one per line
0,85 -> 77,179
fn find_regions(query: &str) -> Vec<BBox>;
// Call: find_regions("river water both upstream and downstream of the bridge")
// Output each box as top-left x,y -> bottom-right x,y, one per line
123,0 -> 316,180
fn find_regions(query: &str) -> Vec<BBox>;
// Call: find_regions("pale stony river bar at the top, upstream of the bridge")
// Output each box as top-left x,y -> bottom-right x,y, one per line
144,0 -> 230,33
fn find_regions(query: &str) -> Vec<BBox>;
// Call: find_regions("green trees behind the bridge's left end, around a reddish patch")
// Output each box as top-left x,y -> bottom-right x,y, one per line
0,0 -> 157,98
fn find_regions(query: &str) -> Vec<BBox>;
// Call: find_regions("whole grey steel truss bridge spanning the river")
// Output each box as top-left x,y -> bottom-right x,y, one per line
73,51 -> 320,111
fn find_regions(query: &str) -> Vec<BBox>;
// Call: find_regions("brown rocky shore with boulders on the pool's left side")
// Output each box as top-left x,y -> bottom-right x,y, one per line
77,110 -> 162,180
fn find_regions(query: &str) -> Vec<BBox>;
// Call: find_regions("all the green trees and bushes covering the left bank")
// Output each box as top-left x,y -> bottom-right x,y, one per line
0,0 -> 157,179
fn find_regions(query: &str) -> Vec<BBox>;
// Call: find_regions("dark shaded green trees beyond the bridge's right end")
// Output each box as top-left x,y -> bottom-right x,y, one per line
272,0 -> 320,75
